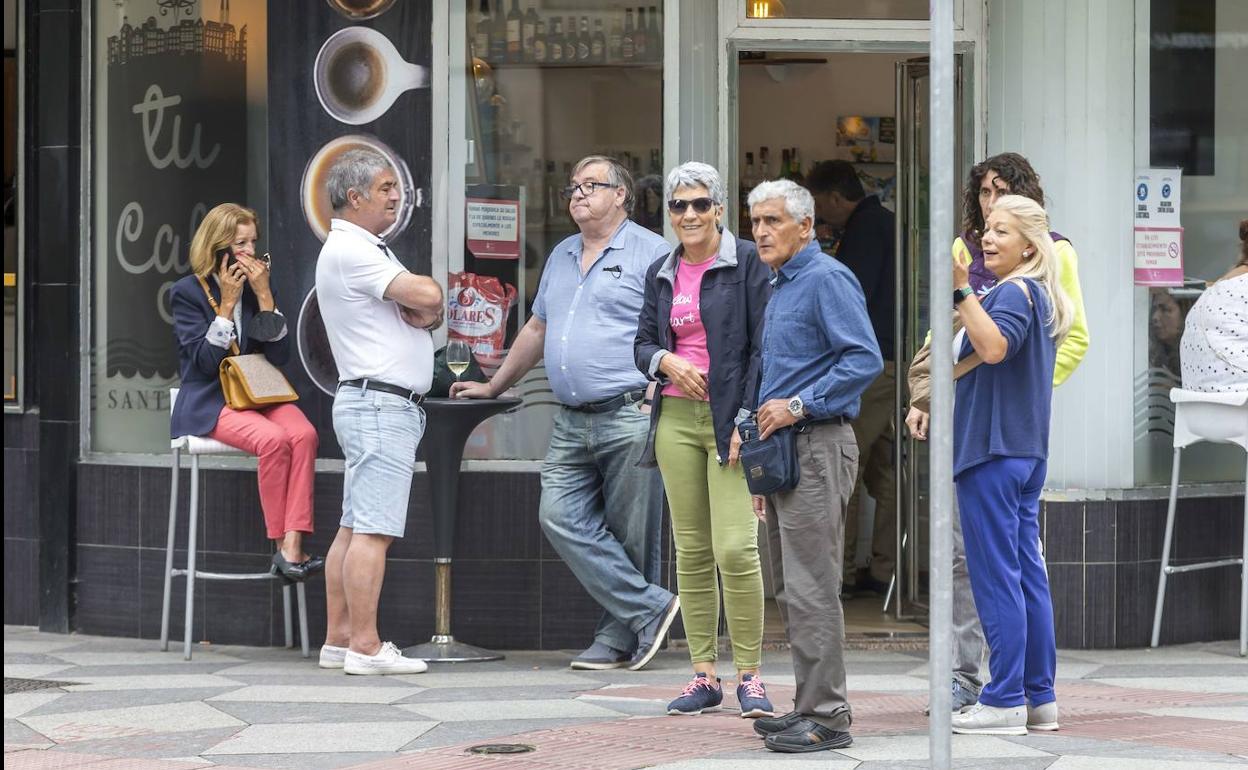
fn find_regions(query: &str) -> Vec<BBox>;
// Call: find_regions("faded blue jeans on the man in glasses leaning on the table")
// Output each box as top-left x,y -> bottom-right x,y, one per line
538,403 -> 673,653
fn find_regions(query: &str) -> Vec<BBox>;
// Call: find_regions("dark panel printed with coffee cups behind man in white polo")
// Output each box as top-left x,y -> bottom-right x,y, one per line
267,0 -> 433,458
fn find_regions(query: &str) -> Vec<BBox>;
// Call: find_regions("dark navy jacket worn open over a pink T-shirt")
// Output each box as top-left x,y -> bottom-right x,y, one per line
633,230 -> 771,468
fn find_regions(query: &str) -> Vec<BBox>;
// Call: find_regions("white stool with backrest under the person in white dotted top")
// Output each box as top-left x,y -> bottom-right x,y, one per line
1152,388 -> 1248,655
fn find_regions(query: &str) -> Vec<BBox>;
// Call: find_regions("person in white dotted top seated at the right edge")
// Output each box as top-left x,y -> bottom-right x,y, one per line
1181,220 -> 1248,393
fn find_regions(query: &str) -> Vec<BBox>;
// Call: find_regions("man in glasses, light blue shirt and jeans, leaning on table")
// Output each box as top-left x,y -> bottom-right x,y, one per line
452,156 -> 680,670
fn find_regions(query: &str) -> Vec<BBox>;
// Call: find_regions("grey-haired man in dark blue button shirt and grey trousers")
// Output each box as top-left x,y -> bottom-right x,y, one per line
749,180 -> 884,753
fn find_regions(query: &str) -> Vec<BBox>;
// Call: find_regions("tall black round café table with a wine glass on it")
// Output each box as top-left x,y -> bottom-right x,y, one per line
403,398 -> 520,663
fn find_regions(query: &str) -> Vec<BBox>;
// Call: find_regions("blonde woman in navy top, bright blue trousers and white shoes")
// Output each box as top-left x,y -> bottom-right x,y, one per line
953,195 -> 1075,735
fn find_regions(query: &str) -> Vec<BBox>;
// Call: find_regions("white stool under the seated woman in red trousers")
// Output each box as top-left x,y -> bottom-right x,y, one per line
160,388 -> 310,660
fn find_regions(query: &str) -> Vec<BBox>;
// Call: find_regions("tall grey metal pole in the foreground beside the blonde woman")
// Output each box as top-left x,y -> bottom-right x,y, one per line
927,0 -> 956,770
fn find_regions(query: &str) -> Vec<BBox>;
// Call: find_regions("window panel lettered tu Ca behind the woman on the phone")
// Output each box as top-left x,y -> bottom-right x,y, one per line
91,0 -> 265,452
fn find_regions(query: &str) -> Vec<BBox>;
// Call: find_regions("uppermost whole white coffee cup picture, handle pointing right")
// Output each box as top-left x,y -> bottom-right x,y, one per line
313,26 -> 429,126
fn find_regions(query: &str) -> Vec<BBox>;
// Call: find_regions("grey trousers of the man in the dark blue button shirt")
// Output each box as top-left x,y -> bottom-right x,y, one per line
768,423 -> 859,730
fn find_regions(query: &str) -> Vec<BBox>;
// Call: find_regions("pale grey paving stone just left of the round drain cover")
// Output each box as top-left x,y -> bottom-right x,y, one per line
203,720 -> 437,759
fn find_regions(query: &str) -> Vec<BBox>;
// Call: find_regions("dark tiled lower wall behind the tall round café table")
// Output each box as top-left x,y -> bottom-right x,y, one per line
76,465 -> 674,649
